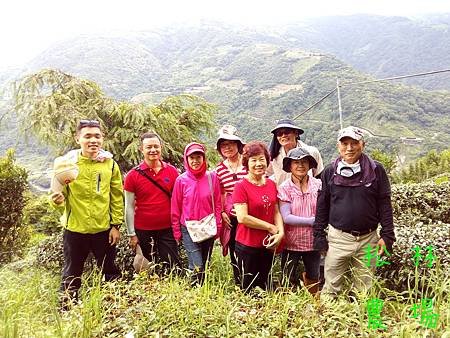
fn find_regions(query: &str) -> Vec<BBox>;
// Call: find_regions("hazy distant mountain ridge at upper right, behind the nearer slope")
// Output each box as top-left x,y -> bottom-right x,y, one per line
283,14 -> 450,90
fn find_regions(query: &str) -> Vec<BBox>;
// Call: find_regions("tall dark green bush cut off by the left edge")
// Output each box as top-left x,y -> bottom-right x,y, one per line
0,149 -> 29,263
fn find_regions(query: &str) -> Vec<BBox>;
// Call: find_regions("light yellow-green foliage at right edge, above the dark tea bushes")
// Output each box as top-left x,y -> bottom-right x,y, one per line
393,149 -> 450,183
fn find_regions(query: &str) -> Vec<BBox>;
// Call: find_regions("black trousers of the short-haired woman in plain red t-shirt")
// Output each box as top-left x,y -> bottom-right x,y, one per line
235,242 -> 274,291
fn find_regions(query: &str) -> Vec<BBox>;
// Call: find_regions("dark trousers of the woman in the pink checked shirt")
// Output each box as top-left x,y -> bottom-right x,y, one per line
281,250 -> 320,285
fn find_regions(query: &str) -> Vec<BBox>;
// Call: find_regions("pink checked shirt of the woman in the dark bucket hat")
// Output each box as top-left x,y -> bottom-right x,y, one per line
278,177 -> 322,251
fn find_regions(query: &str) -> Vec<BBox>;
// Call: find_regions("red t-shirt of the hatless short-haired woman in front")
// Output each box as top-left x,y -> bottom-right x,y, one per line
233,178 -> 278,248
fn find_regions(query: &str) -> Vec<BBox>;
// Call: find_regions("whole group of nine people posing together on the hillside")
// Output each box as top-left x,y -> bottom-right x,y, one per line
51,119 -> 395,304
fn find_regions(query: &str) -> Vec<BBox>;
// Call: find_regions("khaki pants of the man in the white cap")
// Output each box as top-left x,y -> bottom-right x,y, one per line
323,225 -> 379,296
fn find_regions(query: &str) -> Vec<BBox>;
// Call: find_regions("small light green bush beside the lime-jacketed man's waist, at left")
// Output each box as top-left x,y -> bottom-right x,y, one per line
23,194 -> 61,235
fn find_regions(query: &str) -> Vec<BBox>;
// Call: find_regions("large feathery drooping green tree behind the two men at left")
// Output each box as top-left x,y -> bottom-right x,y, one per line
14,69 -> 215,171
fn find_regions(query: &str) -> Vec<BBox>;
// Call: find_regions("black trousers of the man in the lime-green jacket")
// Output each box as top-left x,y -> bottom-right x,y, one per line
61,229 -> 121,298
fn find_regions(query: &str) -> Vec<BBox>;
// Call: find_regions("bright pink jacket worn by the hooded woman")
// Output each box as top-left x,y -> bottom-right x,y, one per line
171,143 -> 222,241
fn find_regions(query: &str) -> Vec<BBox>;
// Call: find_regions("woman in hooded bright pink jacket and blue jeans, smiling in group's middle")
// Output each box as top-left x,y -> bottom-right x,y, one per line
171,142 -> 222,285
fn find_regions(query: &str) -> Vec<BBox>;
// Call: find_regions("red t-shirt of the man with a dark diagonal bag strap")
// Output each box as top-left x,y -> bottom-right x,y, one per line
124,161 -> 178,230
